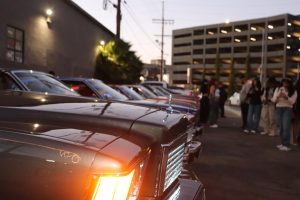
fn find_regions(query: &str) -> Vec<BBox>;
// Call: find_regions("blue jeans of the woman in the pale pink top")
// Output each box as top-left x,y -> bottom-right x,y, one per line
276,107 -> 293,146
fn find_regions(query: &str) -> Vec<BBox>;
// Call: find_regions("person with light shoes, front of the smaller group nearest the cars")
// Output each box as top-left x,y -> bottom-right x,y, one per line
208,84 -> 220,128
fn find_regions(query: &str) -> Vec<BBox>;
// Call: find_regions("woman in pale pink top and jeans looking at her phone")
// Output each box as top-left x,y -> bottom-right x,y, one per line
272,78 -> 297,151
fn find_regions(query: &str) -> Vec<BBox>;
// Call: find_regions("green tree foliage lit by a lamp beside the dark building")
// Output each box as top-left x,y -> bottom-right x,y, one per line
94,39 -> 143,84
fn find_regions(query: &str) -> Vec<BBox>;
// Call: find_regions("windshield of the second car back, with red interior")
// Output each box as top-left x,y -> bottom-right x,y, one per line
87,79 -> 128,101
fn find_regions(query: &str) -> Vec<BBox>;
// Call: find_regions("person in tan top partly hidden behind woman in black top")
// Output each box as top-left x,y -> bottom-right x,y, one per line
240,77 -> 251,130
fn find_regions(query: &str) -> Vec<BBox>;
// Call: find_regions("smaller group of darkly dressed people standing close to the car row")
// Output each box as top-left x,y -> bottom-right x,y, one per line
199,80 -> 227,128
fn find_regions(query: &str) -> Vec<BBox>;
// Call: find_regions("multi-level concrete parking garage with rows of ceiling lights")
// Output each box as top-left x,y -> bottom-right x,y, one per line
172,14 -> 300,83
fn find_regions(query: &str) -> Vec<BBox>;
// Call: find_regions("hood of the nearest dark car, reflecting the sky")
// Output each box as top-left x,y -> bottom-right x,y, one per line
0,92 -> 157,149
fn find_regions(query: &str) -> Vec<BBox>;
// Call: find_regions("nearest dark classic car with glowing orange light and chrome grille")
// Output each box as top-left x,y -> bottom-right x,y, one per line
0,91 -> 205,200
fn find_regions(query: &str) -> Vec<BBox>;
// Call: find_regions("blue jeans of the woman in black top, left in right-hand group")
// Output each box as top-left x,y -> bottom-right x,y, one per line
247,104 -> 262,131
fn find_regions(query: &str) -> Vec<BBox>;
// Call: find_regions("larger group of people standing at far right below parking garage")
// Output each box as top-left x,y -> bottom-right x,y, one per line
240,77 -> 300,151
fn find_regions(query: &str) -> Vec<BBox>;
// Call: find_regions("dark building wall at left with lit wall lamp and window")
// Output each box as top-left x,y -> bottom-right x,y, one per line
0,0 -> 114,76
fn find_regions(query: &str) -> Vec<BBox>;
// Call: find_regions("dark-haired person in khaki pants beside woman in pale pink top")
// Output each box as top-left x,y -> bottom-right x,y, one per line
261,77 -> 277,136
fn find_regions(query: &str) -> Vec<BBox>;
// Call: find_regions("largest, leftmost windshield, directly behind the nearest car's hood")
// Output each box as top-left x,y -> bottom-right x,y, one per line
14,72 -> 79,96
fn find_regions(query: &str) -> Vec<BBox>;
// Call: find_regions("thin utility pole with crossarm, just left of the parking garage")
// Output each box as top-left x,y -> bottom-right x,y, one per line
152,1 -> 174,81
